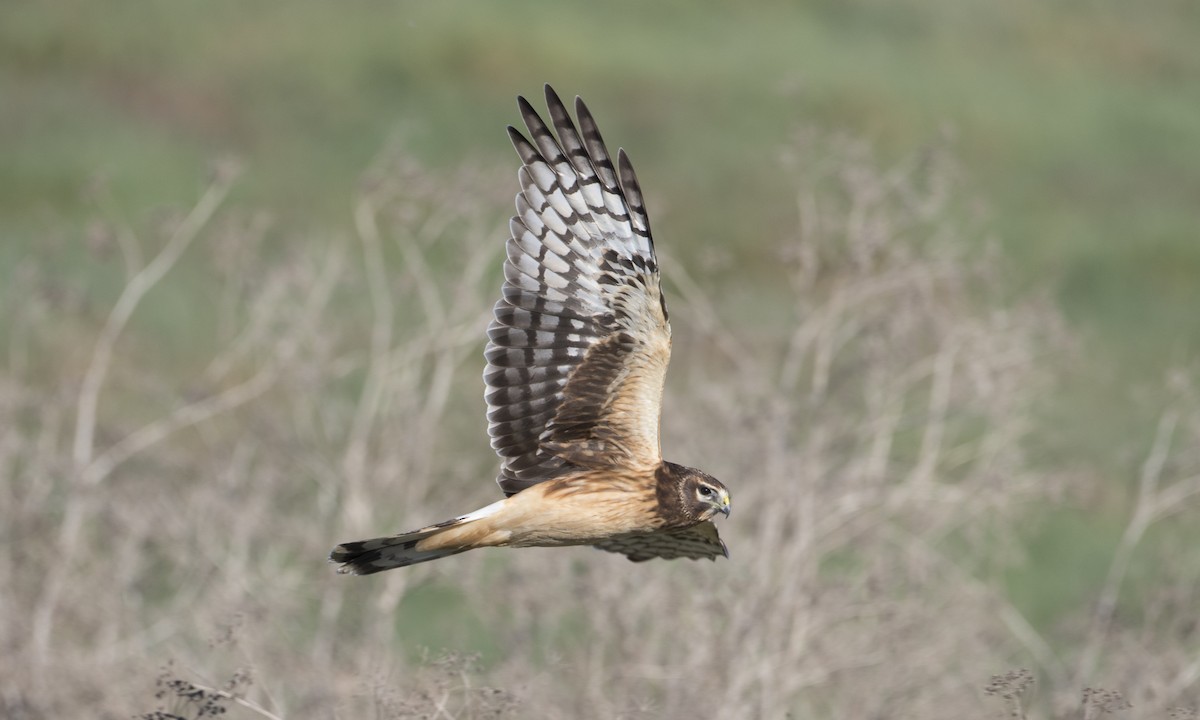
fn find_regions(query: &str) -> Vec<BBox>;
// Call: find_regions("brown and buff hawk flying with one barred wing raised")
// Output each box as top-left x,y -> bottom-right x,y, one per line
330,85 -> 730,575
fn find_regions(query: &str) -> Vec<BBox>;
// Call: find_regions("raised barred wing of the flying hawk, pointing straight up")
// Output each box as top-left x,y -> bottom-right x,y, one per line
484,85 -> 671,494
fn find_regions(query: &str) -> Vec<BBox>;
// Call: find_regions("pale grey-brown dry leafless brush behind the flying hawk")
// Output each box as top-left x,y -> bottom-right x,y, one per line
0,140 -> 1200,719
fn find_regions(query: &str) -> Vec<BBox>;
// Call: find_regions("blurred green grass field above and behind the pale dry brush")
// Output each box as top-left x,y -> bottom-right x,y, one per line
0,0 -> 1200,710
